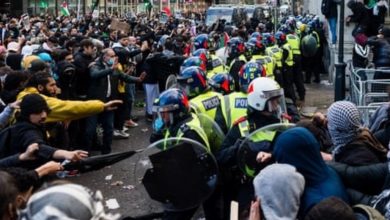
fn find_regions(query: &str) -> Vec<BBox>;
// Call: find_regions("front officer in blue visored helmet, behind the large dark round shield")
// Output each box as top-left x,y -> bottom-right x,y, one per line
150,89 -> 211,219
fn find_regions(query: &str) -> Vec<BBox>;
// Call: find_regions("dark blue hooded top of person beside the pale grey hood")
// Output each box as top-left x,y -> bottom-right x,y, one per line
273,127 -> 348,216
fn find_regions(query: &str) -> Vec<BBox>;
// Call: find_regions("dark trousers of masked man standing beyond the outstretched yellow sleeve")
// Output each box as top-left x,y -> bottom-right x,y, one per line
85,111 -> 114,154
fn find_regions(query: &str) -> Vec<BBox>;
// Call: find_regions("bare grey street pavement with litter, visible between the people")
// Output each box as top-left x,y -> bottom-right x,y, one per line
71,76 -> 334,217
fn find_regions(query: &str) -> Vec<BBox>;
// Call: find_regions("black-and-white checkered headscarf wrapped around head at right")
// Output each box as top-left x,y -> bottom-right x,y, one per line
327,101 -> 362,154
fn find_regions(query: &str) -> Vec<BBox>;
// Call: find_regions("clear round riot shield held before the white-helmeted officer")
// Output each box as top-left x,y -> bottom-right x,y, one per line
237,123 -> 295,177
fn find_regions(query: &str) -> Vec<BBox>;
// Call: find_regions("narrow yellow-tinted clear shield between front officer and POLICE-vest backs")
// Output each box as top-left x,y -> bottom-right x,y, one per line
197,113 -> 225,152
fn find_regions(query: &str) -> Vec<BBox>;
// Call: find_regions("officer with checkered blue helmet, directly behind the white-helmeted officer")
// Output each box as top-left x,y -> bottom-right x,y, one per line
224,61 -> 265,129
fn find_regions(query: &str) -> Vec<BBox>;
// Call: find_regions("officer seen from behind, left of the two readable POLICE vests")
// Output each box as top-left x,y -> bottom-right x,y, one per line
177,67 -> 227,136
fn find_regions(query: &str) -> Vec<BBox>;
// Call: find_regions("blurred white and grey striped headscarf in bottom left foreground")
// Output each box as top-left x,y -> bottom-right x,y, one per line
20,184 -> 120,220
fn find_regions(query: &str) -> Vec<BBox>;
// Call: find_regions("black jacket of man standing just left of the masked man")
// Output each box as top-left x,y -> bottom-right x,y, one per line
73,52 -> 94,96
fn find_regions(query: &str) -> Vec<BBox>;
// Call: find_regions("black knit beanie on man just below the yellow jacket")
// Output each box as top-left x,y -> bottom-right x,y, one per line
20,94 -> 50,119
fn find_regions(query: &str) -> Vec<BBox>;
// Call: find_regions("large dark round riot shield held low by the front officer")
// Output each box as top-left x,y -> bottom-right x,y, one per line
135,138 -> 218,211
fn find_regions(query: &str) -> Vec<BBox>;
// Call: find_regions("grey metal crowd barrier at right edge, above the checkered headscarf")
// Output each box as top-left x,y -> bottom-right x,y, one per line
349,63 -> 390,125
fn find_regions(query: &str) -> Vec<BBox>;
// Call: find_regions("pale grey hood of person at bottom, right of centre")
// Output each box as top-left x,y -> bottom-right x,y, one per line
253,164 -> 305,220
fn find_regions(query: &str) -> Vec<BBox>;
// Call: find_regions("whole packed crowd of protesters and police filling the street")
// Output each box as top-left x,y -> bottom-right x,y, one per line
0,1 -> 390,220
